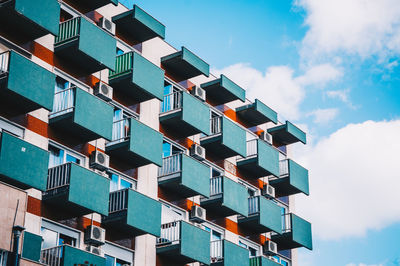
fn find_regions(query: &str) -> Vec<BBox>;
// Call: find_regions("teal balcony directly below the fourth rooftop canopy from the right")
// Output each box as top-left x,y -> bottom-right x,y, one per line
160,91 -> 210,137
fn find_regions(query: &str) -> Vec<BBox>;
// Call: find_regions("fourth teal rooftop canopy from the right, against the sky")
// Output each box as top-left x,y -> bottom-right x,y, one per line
161,46 -> 210,81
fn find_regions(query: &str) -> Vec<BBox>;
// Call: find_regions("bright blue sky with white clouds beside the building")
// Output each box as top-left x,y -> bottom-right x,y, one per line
120,0 -> 400,266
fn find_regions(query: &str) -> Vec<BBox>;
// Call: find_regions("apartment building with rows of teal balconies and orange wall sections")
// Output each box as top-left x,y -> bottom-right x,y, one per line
0,0 -> 312,266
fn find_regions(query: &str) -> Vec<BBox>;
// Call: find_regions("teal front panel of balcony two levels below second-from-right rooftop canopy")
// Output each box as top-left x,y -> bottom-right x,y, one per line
260,196 -> 282,234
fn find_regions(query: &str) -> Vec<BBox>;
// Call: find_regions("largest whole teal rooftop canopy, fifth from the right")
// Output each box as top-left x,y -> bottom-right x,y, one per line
112,5 -> 165,43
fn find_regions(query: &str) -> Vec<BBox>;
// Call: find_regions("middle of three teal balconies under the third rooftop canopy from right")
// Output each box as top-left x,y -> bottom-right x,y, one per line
200,176 -> 248,217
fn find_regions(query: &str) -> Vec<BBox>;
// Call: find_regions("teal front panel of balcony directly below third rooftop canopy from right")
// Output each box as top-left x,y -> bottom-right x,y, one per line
222,117 -> 246,157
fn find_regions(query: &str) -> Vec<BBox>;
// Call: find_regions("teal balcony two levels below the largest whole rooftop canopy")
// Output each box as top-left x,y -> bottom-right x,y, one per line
106,118 -> 163,168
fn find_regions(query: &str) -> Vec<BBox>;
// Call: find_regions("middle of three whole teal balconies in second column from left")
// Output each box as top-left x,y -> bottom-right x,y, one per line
49,87 -> 114,141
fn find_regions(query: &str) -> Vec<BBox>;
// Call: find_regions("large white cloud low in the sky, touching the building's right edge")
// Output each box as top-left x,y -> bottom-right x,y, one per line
295,120 -> 400,240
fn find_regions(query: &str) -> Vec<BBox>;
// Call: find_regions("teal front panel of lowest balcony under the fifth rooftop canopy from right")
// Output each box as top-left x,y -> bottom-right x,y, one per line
126,189 -> 161,237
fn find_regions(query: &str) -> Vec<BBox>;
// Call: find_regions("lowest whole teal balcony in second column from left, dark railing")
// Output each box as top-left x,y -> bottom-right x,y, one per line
42,163 -> 110,217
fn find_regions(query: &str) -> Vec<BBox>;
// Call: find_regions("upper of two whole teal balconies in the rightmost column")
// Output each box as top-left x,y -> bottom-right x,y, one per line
269,159 -> 310,197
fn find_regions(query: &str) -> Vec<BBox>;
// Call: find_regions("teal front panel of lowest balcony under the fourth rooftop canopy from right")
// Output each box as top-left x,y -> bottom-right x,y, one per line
180,221 -> 210,265
